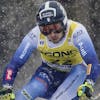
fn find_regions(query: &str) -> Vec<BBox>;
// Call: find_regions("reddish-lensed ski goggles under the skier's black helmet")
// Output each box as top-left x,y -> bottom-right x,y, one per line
39,23 -> 64,36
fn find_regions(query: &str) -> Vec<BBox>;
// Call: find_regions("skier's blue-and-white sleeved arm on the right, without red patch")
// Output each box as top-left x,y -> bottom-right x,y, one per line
73,24 -> 99,82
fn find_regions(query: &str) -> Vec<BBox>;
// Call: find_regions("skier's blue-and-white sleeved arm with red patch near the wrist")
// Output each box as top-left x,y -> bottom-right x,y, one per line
2,27 -> 39,86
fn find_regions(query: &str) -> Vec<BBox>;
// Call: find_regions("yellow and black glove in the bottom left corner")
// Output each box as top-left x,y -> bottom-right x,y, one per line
0,88 -> 15,100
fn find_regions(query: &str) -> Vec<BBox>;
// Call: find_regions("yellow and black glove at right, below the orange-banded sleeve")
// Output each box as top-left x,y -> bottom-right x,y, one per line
77,80 -> 94,100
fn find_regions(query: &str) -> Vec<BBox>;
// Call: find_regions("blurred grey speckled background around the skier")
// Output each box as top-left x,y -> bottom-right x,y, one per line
0,0 -> 100,100
